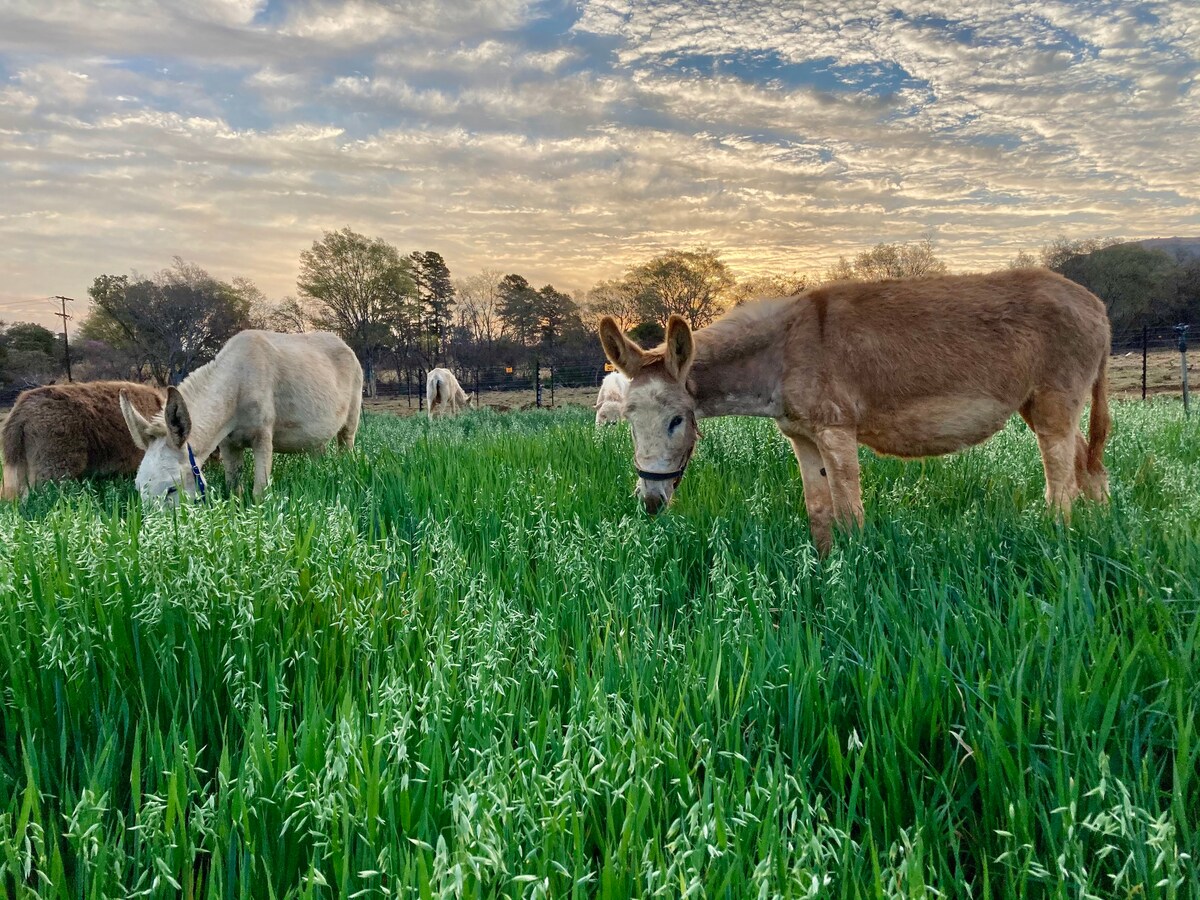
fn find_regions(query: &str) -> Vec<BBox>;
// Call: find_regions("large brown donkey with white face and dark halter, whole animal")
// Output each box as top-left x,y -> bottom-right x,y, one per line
600,269 -> 1111,552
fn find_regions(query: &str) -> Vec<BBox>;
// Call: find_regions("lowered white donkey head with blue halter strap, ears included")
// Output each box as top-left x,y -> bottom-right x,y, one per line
120,388 -> 205,506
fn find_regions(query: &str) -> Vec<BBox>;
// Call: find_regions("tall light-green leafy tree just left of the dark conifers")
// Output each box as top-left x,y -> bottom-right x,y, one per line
296,228 -> 415,397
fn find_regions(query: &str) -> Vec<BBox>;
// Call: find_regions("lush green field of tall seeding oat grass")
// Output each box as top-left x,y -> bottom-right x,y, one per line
0,401 -> 1200,898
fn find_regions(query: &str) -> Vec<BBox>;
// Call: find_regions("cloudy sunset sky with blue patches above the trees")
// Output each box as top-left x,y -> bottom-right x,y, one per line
0,0 -> 1200,325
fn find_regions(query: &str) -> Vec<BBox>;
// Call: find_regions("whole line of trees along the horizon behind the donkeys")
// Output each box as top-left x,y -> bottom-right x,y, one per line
0,228 -> 1200,395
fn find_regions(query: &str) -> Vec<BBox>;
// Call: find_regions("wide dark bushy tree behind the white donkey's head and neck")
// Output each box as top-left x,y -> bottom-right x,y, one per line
79,257 -> 257,384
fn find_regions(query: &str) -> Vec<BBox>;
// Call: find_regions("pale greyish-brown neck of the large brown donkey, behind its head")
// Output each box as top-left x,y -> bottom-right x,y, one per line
688,299 -> 794,419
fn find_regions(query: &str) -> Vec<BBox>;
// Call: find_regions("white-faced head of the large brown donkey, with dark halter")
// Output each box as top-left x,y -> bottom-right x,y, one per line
600,316 -> 700,515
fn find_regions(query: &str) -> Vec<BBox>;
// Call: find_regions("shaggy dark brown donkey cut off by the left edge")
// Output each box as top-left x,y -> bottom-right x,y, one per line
0,382 -> 163,500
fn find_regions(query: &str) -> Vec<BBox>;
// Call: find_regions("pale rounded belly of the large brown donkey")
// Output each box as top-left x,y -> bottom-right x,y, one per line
858,397 -> 1015,457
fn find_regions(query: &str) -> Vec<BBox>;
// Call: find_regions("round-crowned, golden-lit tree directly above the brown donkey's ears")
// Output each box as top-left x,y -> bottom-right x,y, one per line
626,247 -> 733,329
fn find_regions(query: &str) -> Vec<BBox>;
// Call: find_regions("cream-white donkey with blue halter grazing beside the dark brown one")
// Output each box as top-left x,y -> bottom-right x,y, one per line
121,331 -> 362,505
